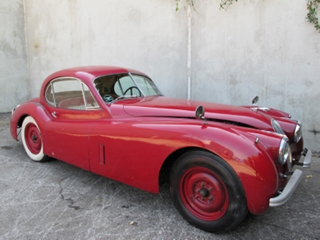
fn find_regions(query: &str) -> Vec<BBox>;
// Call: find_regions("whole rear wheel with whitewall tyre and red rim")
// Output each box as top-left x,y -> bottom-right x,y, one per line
21,116 -> 48,162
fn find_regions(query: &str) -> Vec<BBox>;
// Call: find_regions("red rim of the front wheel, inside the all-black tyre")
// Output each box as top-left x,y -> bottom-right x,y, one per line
179,167 -> 229,221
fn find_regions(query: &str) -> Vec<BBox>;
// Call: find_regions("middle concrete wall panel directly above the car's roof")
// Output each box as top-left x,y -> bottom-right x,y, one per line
25,0 -> 187,97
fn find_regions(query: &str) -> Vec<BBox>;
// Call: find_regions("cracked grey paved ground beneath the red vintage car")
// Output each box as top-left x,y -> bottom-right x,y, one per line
0,114 -> 320,240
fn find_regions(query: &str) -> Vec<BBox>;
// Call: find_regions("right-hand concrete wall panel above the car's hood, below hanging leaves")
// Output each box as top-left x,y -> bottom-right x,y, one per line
192,0 -> 320,151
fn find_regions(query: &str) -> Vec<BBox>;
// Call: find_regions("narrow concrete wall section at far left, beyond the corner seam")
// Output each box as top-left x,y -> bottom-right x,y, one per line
0,0 -> 29,112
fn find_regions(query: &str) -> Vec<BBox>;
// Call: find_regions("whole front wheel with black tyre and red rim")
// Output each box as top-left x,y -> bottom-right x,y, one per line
170,151 -> 248,232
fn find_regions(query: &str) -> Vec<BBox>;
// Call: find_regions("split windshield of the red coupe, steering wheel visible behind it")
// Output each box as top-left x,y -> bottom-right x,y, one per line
94,73 -> 162,103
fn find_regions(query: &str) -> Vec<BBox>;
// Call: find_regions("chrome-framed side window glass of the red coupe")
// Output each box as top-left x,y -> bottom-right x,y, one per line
45,79 -> 99,110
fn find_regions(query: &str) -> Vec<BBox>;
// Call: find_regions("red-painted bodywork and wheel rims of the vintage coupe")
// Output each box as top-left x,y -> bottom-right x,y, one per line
10,67 -> 303,216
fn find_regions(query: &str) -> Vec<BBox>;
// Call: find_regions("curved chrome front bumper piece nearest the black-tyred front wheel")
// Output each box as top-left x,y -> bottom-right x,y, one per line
269,169 -> 302,207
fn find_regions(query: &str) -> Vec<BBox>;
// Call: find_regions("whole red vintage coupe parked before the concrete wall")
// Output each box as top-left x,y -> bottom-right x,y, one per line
11,66 -> 311,232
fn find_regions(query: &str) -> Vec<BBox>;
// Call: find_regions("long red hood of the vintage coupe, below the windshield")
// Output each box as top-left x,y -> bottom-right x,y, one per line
119,97 -> 274,131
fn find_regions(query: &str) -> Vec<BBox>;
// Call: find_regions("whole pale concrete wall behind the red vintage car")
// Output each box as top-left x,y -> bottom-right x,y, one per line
0,0 -> 320,151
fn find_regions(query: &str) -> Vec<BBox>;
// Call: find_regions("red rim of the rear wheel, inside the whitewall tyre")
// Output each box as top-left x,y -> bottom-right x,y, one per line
24,123 -> 42,154
